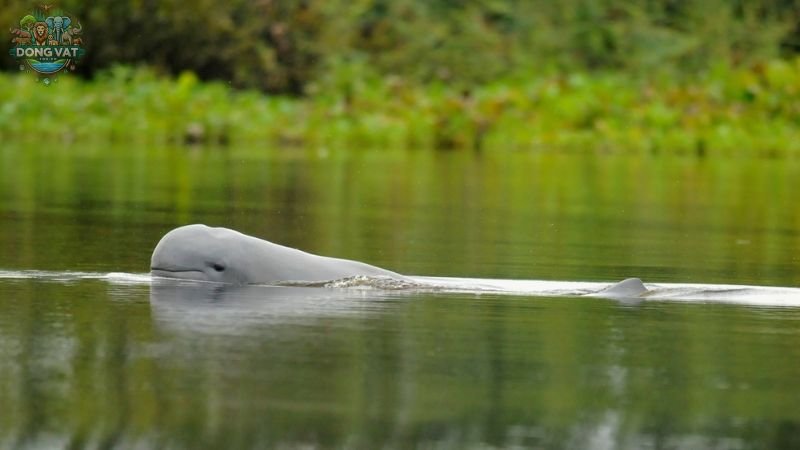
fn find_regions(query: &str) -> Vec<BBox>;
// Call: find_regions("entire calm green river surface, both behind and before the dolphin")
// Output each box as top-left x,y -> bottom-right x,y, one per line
0,144 -> 800,449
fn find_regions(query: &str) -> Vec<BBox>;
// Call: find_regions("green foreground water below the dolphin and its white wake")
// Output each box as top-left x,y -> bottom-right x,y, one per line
0,281 -> 800,448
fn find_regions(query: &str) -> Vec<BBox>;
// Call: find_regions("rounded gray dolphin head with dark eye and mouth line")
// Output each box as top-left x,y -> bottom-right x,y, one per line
150,225 -> 251,284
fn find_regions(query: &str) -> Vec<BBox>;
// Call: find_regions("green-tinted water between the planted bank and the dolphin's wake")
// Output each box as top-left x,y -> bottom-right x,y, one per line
0,144 -> 800,286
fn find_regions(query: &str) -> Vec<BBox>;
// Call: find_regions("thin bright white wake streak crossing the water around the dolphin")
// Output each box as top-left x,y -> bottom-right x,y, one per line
0,269 -> 800,308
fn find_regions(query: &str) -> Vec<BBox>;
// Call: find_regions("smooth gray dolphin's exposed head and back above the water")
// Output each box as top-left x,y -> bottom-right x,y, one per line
150,224 -> 405,285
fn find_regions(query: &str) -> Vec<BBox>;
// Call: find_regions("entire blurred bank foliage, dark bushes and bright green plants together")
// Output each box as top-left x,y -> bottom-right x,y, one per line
0,0 -> 800,154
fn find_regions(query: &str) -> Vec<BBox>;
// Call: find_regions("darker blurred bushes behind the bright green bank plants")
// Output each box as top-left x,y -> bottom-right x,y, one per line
0,0 -> 800,94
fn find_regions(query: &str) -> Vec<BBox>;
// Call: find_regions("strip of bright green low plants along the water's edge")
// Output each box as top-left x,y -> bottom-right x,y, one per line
0,59 -> 800,155
